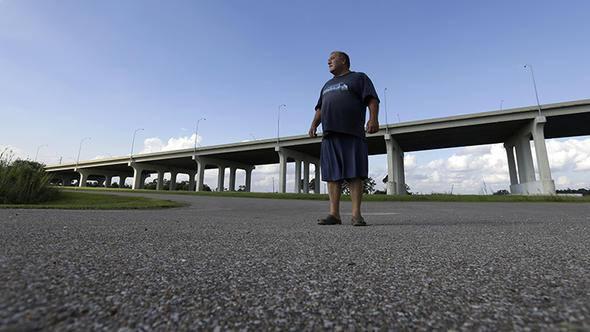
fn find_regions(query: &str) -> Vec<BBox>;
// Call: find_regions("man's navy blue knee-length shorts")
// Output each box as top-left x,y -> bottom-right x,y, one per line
320,133 -> 369,182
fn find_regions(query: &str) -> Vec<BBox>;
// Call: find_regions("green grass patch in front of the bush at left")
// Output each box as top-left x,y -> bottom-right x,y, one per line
0,191 -> 185,210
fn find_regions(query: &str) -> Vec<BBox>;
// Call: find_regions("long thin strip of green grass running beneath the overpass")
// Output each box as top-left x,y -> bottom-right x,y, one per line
63,187 -> 590,203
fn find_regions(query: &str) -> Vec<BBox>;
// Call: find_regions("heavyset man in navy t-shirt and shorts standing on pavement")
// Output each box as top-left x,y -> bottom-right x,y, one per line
309,51 -> 379,226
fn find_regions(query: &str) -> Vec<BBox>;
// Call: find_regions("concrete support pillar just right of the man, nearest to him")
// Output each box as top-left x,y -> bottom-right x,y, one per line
385,135 -> 406,195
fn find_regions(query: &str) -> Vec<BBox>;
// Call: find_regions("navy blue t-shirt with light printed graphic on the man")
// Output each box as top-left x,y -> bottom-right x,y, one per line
315,72 -> 379,138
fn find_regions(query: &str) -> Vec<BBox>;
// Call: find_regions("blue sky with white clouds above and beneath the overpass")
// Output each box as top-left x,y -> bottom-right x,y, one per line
0,0 -> 590,192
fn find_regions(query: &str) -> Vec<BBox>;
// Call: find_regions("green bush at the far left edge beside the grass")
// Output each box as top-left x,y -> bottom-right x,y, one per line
0,151 -> 59,204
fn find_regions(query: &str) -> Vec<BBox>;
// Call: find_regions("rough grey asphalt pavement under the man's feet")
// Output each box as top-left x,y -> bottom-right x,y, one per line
0,195 -> 590,331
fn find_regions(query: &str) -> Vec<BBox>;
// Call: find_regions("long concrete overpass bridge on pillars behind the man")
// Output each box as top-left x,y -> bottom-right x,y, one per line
46,99 -> 590,195
